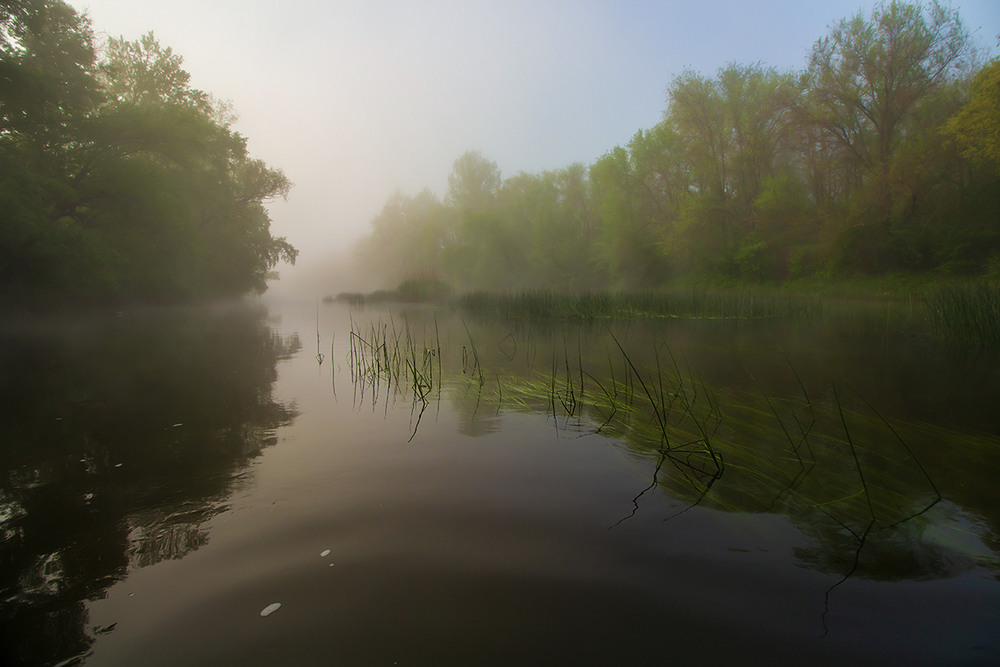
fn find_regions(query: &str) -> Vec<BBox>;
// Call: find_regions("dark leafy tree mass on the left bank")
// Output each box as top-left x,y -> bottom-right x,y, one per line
0,0 -> 296,301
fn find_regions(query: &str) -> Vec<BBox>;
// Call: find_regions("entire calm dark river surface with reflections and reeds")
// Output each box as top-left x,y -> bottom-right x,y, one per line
0,303 -> 1000,665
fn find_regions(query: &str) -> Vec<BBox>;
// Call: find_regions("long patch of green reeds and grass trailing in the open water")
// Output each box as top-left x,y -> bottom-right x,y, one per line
342,319 -> 941,537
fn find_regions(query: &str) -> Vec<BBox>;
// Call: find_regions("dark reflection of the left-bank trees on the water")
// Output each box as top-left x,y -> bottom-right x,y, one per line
0,306 -> 301,664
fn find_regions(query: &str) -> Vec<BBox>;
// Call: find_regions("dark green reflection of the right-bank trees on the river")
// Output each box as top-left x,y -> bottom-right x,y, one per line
346,311 -> 1000,581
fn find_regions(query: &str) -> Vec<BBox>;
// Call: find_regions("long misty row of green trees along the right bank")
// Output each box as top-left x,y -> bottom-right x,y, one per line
355,2 -> 1000,290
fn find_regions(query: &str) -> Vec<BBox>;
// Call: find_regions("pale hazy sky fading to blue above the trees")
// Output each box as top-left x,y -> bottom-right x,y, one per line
69,0 -> 1000,280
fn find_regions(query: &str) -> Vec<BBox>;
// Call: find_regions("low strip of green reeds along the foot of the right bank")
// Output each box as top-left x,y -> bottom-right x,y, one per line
332,280 -> 1000,348
